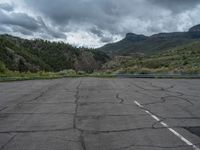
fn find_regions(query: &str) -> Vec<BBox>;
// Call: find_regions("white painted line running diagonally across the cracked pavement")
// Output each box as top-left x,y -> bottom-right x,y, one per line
134,101 -> 200,150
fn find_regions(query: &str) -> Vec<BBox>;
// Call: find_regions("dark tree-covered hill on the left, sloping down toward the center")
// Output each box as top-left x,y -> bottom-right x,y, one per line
0,35 -> 109,72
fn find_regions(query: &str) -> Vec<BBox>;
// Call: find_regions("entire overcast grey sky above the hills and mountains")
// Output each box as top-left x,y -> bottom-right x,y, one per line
0,0 -> 200,47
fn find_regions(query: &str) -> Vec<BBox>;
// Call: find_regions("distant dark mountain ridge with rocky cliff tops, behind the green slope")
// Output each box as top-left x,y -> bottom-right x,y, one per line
99,25 -> 200,55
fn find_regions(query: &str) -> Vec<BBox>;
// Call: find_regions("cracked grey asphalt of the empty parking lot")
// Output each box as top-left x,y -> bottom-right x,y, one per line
0,78 -> 200,150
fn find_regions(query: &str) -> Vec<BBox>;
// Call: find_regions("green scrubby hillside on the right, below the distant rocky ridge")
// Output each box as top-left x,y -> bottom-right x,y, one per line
104,41 -> 200,73
